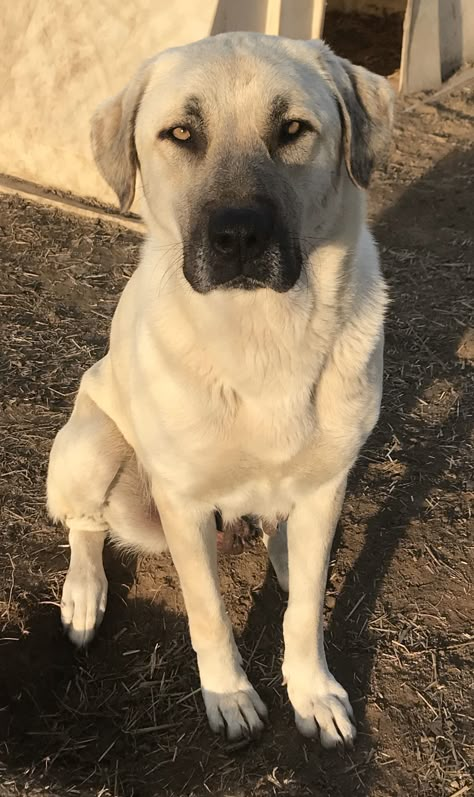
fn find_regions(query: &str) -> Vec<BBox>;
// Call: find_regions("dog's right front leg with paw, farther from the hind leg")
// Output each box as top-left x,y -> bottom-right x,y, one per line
283,473 -> 355,747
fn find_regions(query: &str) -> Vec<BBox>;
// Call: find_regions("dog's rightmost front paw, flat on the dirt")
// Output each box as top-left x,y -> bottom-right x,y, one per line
287,673 -> 356,748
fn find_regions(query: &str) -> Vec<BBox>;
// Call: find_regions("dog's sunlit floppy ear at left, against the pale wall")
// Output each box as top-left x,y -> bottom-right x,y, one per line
91,60 -> 153,213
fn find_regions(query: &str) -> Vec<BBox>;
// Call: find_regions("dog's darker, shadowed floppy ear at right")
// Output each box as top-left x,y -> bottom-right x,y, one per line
323,46 -> 394,188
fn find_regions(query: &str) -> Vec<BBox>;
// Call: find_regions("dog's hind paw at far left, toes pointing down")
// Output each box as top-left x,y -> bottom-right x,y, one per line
61,567 -> 107,647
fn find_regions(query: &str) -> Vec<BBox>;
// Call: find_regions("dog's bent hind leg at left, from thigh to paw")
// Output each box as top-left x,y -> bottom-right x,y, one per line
47,386 -> 130,646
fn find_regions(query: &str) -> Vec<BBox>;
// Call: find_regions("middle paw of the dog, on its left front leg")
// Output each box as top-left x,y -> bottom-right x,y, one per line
202,684 -> 267,742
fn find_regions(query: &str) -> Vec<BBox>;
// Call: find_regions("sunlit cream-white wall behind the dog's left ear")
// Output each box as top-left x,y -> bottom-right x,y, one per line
0,0 -> 218,203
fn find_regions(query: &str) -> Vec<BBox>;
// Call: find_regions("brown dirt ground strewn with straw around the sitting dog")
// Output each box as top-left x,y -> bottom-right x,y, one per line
0,82 -> 474,797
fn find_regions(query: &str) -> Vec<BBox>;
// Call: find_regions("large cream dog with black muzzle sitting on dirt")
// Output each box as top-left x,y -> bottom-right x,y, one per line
47,33 -> 393,748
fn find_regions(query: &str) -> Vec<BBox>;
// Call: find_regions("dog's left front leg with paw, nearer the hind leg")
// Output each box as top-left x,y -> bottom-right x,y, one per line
153,488 -> 267,740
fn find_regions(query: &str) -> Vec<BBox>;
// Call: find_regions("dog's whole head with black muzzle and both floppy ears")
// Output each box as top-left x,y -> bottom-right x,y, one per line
92,33 -> 392,293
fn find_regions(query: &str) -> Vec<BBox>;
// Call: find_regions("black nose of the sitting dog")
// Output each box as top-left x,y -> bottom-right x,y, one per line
208,207 -> 273,266
